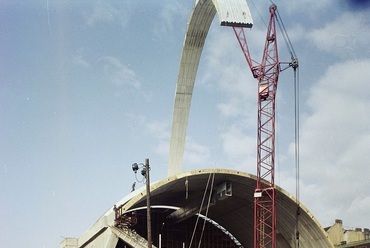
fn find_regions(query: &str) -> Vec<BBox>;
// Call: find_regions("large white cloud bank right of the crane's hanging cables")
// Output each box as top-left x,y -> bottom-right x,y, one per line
292,60 -> 370,225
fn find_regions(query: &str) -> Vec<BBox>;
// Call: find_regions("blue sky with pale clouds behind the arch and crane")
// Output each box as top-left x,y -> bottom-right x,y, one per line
0,0 -> 370,248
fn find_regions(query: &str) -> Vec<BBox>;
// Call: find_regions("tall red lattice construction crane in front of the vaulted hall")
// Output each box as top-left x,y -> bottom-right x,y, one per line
233,4 -> 299,248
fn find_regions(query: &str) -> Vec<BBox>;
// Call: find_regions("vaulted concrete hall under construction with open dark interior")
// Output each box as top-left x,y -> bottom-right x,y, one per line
61,169 -> 333,248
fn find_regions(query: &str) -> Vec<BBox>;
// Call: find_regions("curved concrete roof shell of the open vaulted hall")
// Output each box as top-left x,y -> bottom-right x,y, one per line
122,169 -> 333,248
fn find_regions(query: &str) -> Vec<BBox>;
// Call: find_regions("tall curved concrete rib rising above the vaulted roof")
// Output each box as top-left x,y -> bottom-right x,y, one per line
168,0 -> 253,176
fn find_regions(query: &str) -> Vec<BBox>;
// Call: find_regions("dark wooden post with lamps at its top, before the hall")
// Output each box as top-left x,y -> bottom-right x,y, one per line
132,158 -> 152,248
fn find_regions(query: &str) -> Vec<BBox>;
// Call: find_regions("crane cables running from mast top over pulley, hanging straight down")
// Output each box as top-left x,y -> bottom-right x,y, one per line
271,6 -> 301,248
